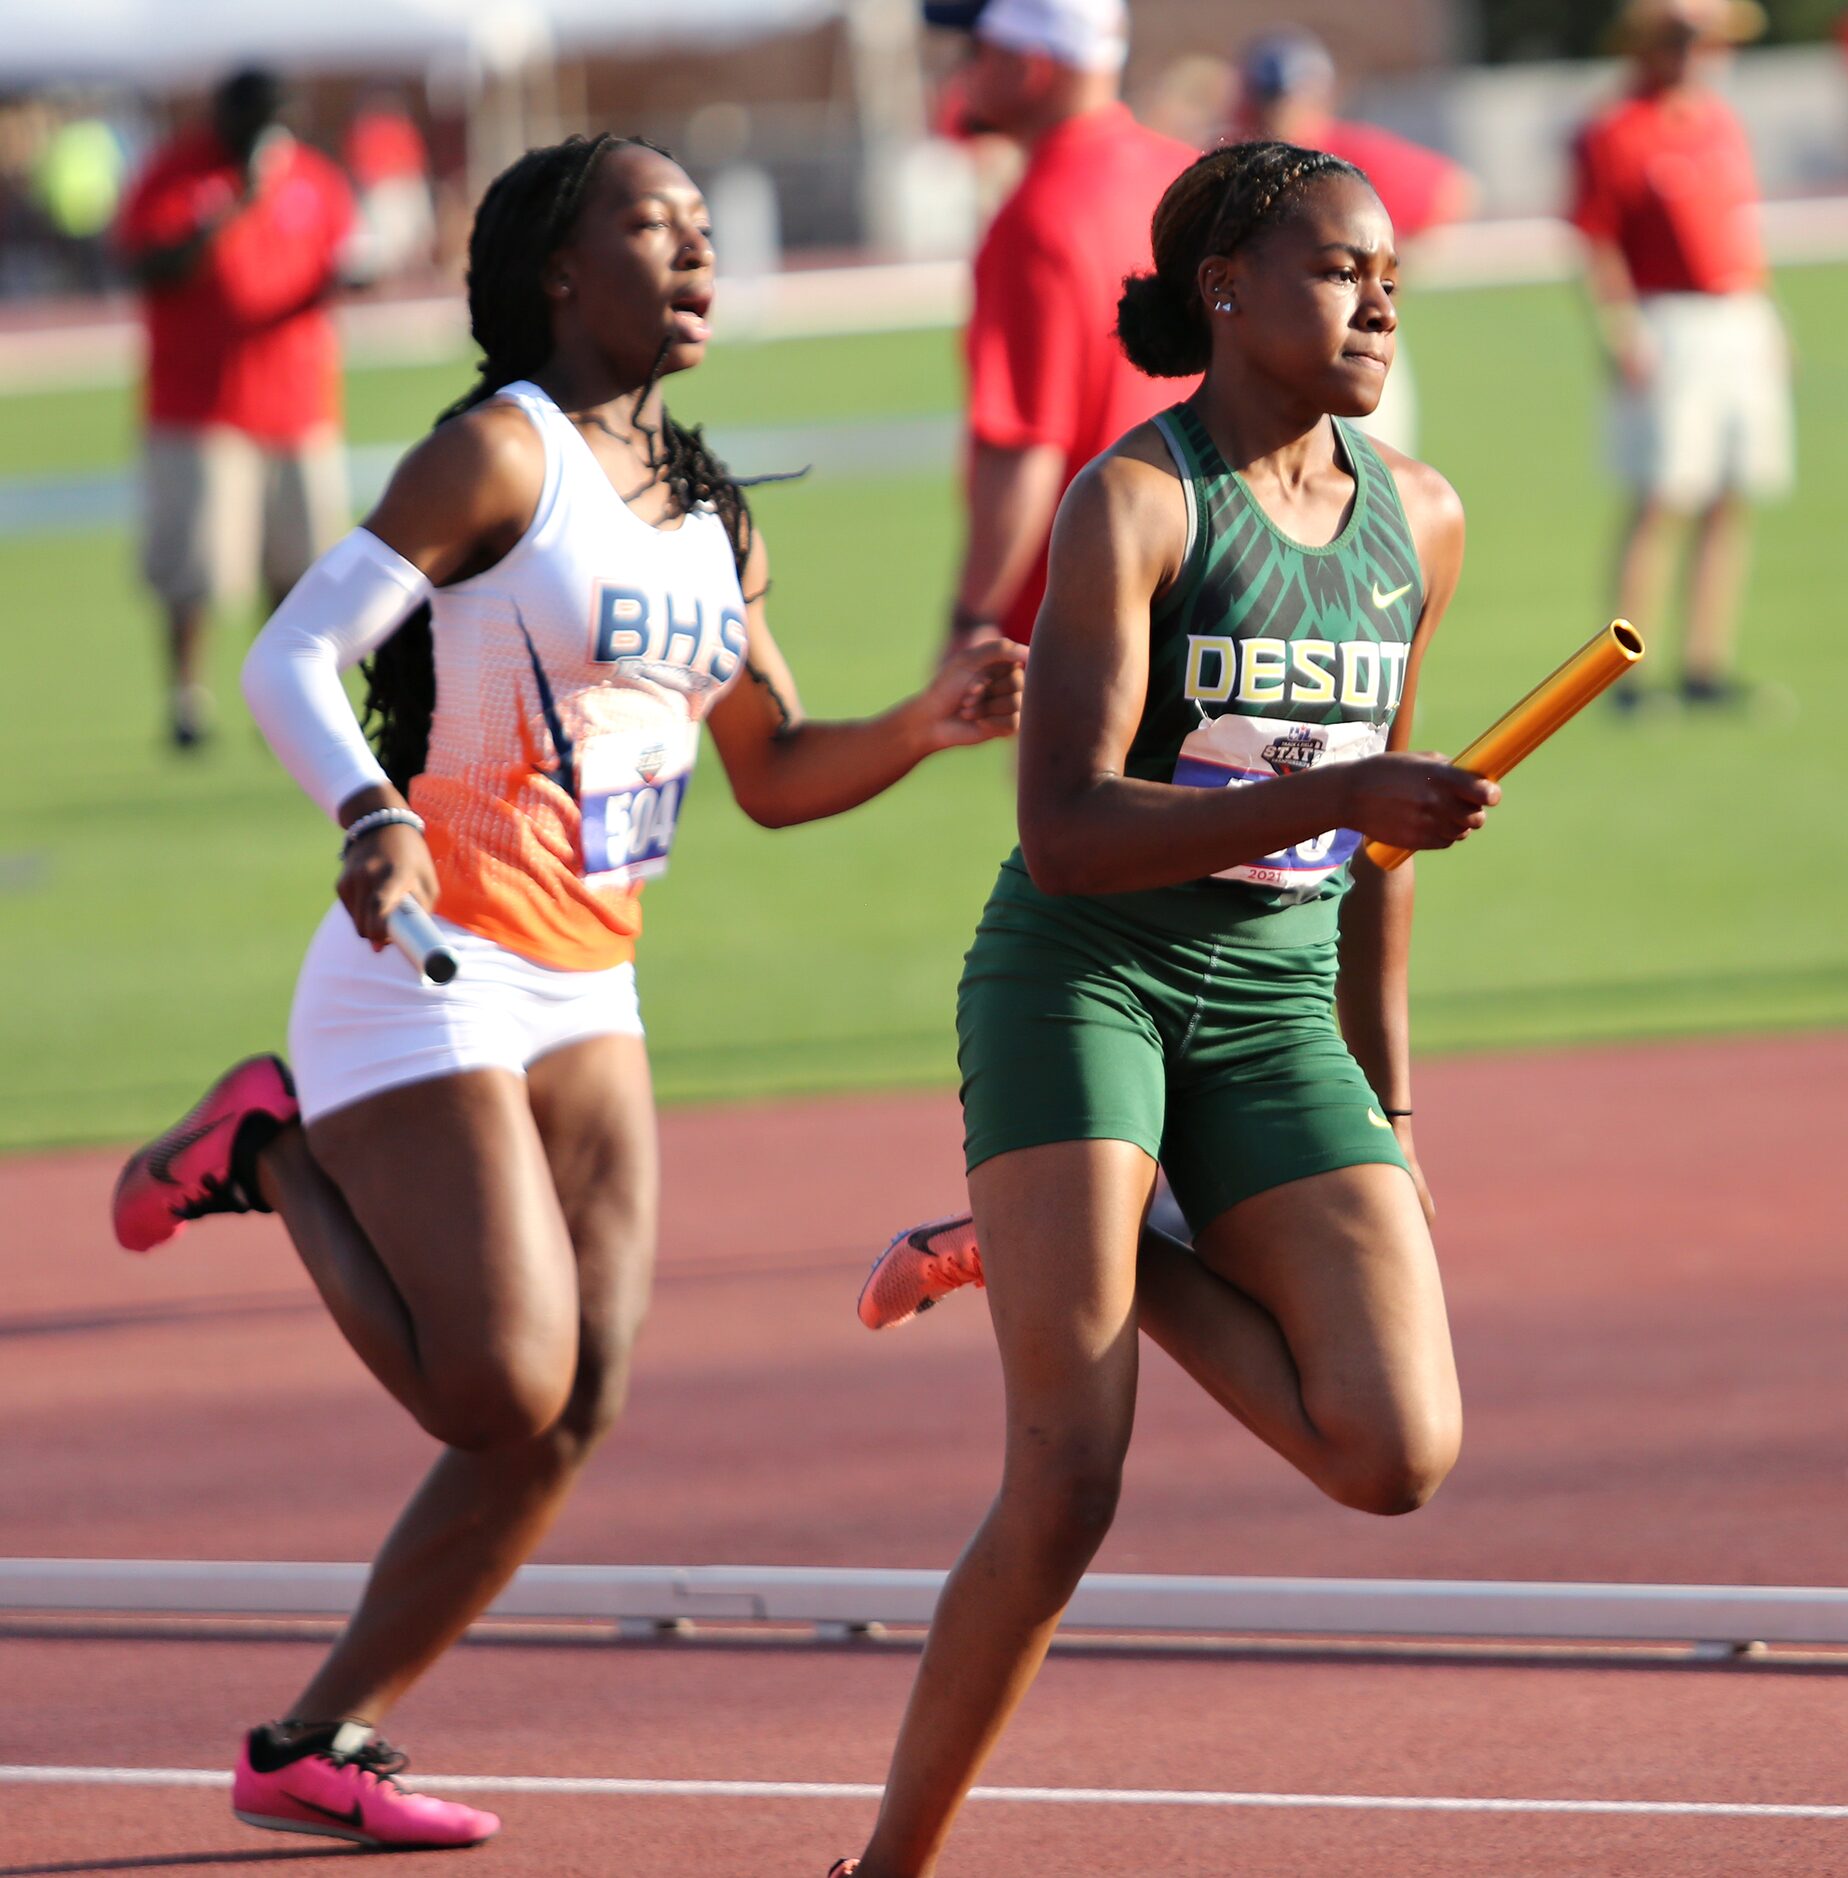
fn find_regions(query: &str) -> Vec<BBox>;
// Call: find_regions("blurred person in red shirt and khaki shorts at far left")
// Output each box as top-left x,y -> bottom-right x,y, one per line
116,69 -> 353,749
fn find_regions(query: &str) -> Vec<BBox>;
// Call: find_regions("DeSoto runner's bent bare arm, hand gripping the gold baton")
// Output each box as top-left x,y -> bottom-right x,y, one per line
1020,426 -> 1480,894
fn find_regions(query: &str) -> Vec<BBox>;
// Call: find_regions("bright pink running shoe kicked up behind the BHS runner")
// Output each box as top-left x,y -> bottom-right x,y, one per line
113,1057 -> 300,1253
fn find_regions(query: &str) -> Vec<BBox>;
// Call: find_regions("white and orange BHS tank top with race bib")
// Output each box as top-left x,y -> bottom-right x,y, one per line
411,379 -> 746,971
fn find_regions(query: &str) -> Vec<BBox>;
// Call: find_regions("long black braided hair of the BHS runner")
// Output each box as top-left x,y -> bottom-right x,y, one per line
364,135 -> 751,789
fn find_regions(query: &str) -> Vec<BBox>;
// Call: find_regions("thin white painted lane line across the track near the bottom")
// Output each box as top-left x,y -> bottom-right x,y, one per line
0,1765 -> 1848,1820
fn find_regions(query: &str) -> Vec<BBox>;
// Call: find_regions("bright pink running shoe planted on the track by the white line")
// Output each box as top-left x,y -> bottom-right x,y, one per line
231,1722 -> 500,1852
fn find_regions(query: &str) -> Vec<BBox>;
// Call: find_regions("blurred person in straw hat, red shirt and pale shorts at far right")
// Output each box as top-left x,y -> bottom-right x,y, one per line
1572,0 -> 1794,706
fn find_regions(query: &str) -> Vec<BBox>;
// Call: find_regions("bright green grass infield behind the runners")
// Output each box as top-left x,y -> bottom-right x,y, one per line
0,269 -> 1848,1147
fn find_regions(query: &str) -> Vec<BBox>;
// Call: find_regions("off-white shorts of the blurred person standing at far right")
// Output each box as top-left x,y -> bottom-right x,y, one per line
1611,293 -> 1794,511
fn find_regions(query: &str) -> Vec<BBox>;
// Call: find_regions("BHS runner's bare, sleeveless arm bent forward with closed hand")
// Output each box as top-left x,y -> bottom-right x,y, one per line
708,535 -> 1024,828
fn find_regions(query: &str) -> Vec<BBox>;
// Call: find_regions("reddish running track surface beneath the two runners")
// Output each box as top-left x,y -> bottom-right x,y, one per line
0,1037 -> 1848,1878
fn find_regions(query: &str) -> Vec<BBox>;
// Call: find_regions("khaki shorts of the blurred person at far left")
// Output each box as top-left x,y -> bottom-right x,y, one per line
141,424 -> 353,607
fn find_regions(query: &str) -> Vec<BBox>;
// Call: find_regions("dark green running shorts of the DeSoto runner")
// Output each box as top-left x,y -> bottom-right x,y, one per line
956,854 -> 1405,1232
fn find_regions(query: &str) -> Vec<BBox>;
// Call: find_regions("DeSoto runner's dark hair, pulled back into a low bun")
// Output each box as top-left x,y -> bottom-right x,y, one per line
1117,143 -> 1367,377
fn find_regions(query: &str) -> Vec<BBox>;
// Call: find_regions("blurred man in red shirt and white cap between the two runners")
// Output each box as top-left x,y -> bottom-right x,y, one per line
924,0 -> 1196,650
